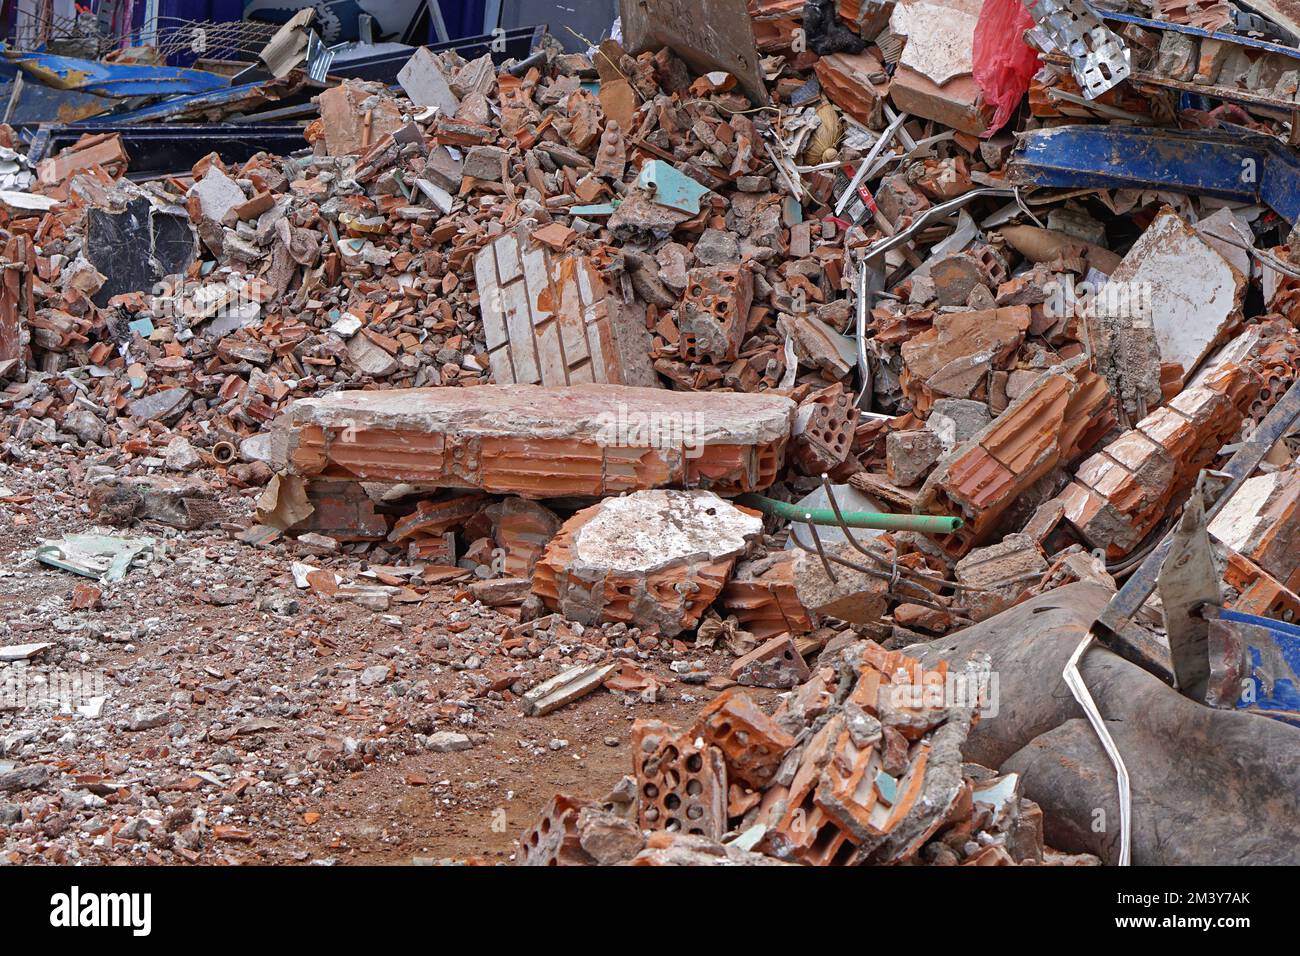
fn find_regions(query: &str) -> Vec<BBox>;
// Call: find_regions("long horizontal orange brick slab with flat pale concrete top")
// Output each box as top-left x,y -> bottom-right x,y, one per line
272,385 -> 794,498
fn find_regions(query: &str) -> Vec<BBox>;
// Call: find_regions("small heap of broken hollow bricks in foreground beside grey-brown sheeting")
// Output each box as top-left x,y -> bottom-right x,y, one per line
519,639 -> 1097,866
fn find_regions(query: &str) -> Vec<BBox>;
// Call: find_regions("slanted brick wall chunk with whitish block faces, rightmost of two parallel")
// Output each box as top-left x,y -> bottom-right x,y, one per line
1057,363 -> 1260,561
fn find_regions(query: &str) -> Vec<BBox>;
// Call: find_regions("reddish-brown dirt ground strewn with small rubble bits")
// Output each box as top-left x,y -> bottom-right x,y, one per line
0,449 -> 731,865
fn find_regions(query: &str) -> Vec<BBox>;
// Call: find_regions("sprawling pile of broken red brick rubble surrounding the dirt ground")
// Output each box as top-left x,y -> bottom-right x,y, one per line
0,0 -> 1300,865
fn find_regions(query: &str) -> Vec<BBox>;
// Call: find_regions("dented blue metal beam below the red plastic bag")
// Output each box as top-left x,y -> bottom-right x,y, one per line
1010,126 -> 1300,225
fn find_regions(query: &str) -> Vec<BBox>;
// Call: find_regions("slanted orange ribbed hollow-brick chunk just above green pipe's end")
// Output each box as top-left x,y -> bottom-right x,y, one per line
915,358 -> 1113,558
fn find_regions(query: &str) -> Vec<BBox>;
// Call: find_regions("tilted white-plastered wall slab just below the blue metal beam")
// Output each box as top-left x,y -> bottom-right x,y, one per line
1092,207 -> 1245,401
